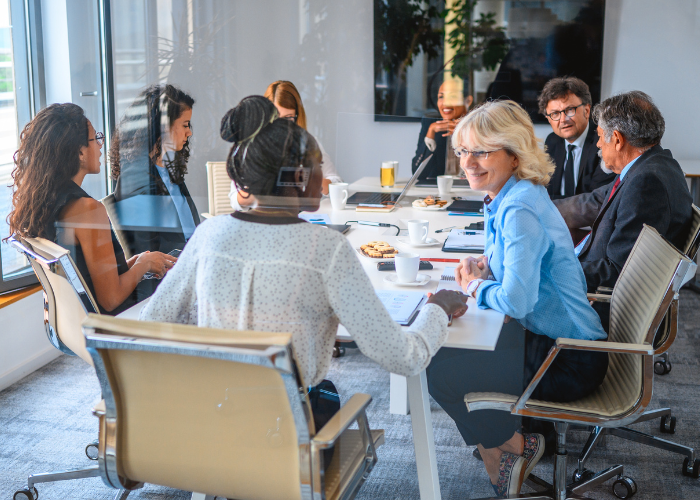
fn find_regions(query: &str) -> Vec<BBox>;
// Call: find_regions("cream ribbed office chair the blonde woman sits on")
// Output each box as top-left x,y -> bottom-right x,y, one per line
464,225 -> 698,500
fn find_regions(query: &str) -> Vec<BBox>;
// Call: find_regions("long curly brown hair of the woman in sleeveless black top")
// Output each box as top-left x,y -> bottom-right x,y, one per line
7,103 -> 88,238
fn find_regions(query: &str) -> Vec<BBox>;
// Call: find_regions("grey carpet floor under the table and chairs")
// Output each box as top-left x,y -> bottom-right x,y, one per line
0,291 -> 700,500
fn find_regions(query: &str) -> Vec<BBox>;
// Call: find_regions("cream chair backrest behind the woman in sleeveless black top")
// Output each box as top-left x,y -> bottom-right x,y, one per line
10,236 -> 99,365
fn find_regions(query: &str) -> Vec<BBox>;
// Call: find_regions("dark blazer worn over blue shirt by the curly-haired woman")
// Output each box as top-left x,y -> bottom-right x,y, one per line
114,158 -> 200,255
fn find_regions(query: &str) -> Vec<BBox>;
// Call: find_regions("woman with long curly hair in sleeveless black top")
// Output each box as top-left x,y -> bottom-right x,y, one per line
8,103 -> 177,314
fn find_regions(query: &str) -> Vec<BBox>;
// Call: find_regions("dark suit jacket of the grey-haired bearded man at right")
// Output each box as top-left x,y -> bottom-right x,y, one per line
554,145 -> 693,292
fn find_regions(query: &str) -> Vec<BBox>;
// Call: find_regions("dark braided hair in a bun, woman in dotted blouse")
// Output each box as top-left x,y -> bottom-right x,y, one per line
220,96 -> 321,196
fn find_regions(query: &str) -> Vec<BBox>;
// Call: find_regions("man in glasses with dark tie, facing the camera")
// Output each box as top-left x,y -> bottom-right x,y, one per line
538,77 -> 615,200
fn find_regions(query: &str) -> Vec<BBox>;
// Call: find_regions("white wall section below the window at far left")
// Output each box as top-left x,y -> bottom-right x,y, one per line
0,292 -> 61,391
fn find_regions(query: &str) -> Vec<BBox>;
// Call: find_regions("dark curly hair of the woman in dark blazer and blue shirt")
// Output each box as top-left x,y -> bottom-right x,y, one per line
109,84 -> 194,190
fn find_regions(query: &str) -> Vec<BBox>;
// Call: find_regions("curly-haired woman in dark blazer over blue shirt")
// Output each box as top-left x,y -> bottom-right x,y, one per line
109,85 -> 199,254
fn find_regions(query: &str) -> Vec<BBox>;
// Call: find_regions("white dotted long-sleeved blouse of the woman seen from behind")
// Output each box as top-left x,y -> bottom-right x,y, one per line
141,212 -> 447,386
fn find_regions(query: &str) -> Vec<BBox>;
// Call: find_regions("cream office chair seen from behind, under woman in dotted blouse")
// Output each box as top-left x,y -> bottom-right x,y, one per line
83,315 -> 384,500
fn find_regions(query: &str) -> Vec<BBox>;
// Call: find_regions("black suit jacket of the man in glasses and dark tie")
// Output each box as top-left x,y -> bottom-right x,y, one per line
544,122 -> 615,200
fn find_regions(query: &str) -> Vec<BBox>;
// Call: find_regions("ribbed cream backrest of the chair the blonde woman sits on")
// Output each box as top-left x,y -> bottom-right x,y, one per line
603,224 -> 692,416
